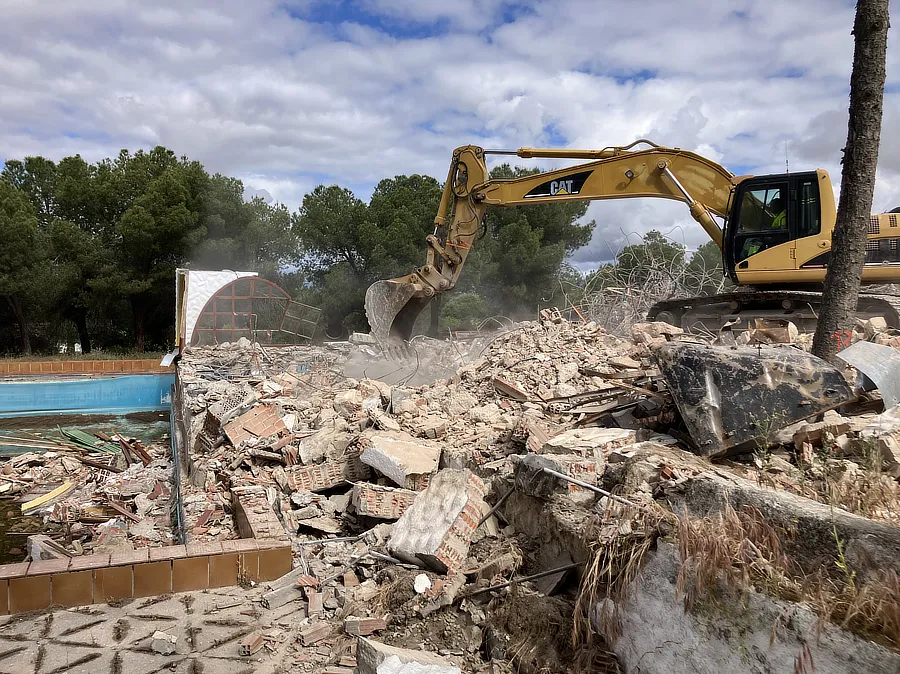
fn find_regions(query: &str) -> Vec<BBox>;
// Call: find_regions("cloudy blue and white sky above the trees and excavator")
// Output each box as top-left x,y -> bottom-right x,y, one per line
0,0 -> 900,268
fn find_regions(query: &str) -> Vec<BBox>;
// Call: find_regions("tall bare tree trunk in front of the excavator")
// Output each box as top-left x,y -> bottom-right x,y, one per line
812,0 -> 890,361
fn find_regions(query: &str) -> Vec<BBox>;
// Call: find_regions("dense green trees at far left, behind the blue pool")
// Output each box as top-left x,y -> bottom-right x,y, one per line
0,147 -> 301,351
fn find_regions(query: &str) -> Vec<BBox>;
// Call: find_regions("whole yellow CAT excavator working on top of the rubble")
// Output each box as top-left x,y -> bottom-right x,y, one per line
366,139 -> 900,340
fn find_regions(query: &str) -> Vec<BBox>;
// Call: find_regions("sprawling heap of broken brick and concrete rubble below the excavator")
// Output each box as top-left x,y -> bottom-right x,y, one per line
19,311 -> 864,674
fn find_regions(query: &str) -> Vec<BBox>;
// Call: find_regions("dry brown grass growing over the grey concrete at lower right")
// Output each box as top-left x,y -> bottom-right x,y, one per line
677,508 -> 900,650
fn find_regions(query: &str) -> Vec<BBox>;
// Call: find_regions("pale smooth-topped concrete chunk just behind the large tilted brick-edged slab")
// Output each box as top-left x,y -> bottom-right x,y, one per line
359,431 -> 441,491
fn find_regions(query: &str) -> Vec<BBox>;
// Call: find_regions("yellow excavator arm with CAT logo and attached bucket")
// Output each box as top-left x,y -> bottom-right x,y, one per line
366,140 -> 740,340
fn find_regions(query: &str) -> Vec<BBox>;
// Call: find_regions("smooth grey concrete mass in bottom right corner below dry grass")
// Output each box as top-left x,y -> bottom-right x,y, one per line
594,541 -> 900,674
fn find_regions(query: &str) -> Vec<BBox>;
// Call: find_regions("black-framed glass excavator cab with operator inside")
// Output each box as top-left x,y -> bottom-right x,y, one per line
723,172 -> 821,282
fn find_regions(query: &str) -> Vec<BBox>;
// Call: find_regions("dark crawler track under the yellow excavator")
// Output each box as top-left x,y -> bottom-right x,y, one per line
647,289 -> 900,332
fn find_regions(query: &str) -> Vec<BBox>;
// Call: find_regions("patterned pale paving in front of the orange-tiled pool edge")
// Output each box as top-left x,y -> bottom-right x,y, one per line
0,588 -> 324,674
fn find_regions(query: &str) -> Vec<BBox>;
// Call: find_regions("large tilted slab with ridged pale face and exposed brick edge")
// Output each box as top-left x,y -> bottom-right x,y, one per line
388,468 -> 487,573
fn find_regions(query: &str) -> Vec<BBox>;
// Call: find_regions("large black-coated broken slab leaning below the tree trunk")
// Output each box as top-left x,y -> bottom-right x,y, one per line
655,342 -> 854,456
